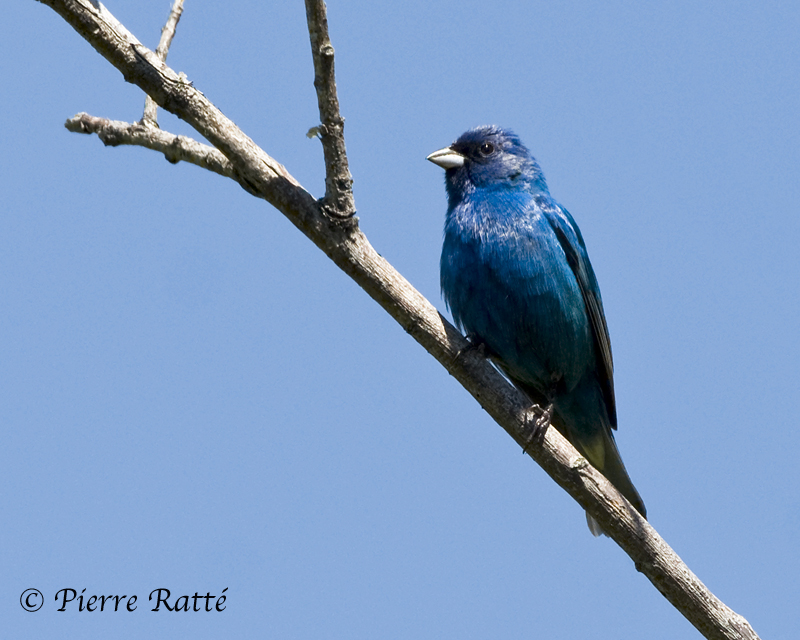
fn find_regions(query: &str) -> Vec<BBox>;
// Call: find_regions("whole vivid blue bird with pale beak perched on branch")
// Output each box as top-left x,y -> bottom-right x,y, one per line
428,126 -> 646,535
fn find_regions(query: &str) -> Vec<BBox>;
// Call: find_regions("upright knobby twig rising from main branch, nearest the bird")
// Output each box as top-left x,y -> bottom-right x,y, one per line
305,0 -> 356,218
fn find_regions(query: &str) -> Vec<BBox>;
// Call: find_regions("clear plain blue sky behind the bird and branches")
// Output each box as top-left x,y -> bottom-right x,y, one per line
0,0 -> 800,640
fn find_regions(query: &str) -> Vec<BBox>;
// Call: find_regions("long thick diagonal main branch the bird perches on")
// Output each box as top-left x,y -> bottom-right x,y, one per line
39,0 -> 758,640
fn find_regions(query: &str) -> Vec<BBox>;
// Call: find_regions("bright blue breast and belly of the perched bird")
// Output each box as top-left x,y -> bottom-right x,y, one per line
441,210 -> 594,392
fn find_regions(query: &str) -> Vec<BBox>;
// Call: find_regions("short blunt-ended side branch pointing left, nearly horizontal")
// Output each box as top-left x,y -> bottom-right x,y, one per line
64,112 -> 236,179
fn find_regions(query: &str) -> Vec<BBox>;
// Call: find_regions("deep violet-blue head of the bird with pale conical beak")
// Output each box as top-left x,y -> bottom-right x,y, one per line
428,126 -> 548,200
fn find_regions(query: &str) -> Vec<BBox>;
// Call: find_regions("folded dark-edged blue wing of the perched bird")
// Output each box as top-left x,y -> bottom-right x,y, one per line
542,203 -> 617,429
